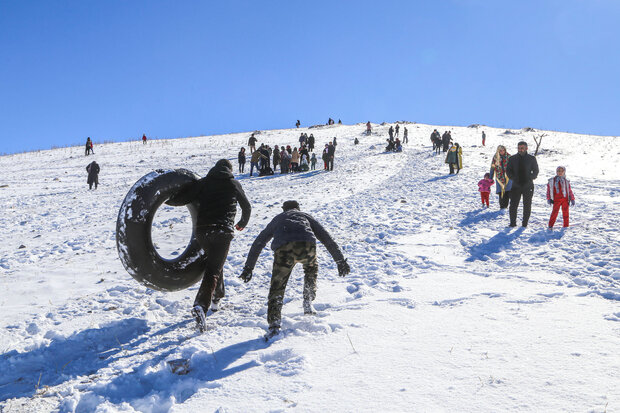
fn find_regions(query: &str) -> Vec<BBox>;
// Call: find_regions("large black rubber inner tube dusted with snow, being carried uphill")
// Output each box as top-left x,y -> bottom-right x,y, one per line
116,169 -> 206,291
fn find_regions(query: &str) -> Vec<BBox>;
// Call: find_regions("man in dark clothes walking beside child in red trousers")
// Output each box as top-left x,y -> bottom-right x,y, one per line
506,141 -> 538,227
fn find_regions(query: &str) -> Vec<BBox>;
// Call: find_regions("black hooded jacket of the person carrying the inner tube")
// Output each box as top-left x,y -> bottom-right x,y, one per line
173,161 -> 252,233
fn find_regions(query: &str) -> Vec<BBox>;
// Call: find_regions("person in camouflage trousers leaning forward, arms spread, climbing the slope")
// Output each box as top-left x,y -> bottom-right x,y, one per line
239,201 -> 351,338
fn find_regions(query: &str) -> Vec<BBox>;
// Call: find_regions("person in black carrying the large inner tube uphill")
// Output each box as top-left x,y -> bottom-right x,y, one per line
173,159 -> 252,331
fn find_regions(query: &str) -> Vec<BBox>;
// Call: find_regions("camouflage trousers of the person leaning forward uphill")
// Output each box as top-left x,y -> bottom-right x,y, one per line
267,242 -> 319,327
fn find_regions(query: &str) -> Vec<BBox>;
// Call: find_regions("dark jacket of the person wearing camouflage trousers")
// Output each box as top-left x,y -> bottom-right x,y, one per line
245,209 -> 344,269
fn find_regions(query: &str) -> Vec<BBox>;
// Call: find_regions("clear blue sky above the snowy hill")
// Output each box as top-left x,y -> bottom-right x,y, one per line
0,0 -> 620,153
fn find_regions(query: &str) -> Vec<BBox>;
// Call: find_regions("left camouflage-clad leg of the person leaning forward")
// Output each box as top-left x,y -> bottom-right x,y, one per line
267,244 -> 295,328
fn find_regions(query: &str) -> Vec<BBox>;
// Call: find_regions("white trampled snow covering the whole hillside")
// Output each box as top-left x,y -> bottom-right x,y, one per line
0,123 -> 620,412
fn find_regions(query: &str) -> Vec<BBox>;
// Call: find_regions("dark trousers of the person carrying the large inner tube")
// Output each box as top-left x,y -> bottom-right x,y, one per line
194,232 -> 233,313
